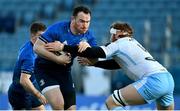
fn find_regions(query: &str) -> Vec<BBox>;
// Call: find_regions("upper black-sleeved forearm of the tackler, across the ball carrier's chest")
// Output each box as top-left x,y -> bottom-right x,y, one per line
63,45 -> 106,58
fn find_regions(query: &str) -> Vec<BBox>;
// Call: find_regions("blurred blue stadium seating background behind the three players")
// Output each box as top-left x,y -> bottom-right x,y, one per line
0,0 -> 180,110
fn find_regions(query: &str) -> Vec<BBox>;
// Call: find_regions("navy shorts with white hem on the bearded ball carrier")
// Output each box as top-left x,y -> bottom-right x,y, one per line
34,68 -> 75,92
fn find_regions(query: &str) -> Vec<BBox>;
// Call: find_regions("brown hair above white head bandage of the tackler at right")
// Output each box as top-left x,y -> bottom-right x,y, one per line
110,21 -> 133,36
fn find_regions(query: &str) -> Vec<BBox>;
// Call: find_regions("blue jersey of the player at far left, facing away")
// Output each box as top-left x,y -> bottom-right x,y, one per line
13,41 -> 36,91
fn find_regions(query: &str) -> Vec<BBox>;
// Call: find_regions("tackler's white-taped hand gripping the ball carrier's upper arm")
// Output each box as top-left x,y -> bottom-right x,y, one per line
45,41 -> 64,52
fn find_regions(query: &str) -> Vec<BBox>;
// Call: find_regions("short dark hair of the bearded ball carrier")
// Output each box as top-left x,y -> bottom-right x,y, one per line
72,5 -> 91,16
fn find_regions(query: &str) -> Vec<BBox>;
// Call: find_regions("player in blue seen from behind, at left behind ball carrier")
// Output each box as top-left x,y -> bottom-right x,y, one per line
8,22 -> 47,110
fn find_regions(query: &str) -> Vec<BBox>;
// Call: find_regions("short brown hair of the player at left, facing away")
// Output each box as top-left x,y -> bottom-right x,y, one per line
30,22 -> 47,34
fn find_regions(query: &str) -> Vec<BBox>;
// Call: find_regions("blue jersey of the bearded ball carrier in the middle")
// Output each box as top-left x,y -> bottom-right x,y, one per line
36,21 -> 97,69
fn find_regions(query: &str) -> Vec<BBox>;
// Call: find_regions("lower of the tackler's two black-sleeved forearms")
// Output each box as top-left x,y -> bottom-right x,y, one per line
93,59 -> 121,70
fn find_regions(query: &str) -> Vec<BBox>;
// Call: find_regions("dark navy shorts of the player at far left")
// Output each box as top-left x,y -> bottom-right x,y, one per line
8,84 -> 42,110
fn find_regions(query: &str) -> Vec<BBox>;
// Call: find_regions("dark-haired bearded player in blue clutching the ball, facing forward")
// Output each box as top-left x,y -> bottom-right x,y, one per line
34,6 -> 96,110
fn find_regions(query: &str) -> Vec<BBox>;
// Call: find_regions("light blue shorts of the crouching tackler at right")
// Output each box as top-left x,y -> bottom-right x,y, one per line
133,72 -> 174,106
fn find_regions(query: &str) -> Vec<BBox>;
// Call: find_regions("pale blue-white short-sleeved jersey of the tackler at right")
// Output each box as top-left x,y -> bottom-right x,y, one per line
101,37 -> 167,81
